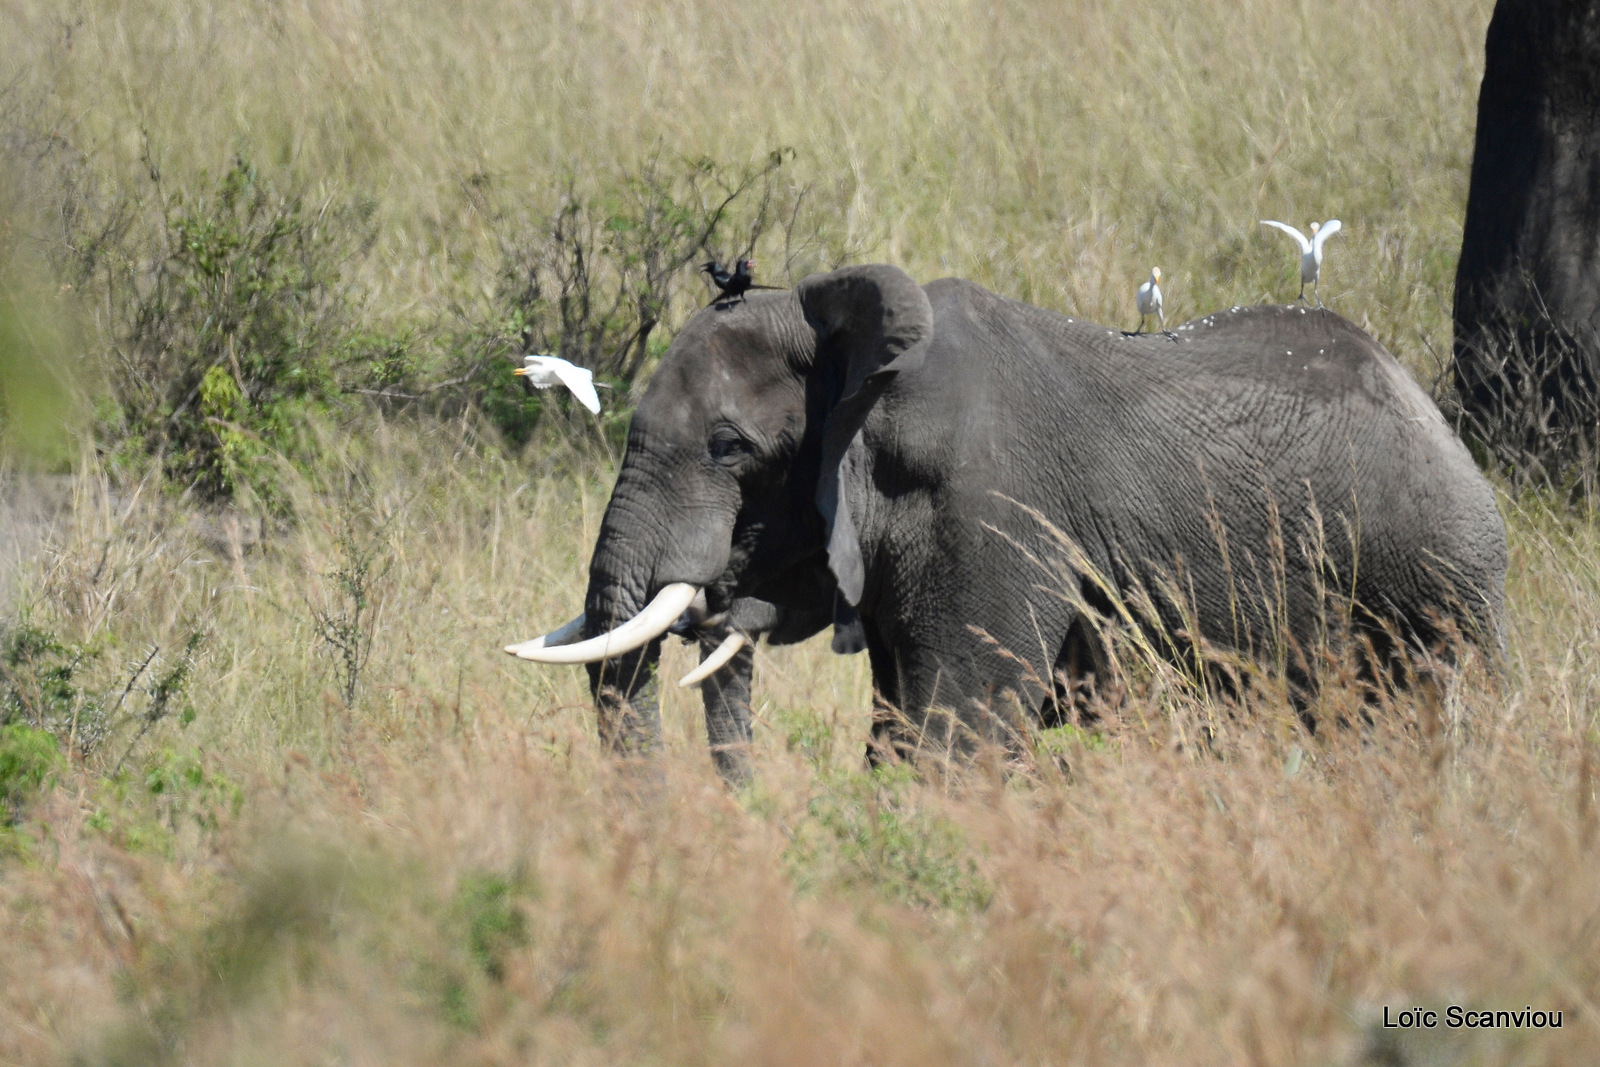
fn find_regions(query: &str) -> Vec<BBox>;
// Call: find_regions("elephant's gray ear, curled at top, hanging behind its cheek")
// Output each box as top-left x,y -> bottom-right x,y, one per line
797,264 -> 933,605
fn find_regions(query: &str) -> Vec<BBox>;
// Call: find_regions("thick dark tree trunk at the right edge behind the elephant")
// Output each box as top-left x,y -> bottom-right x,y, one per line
1453,0 -> 1600,480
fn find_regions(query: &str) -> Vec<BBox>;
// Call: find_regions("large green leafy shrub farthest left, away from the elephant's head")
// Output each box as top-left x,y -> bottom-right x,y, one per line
90,155 -> 380,506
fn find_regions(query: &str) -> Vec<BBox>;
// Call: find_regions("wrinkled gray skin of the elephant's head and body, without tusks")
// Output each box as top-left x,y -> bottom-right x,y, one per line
586,266 -> 1506,767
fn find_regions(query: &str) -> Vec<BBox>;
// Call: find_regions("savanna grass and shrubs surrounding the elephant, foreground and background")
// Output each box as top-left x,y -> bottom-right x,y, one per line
0,0 -> 1600,1067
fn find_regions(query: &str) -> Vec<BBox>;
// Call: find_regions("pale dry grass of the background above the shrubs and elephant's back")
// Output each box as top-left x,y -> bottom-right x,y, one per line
0,0 -> 1491,366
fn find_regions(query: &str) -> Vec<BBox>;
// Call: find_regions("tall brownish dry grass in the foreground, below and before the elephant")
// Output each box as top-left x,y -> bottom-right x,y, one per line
0,424 -> 1600,1064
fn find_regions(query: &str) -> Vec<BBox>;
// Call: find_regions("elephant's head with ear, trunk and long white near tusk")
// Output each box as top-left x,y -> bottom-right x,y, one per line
506,266 -> 933,752
